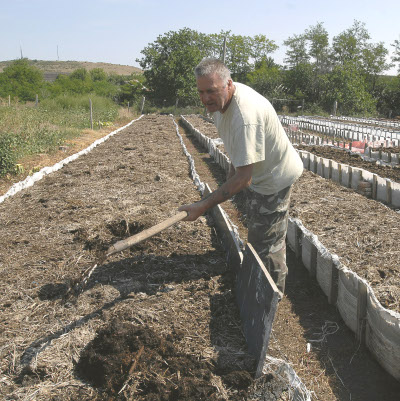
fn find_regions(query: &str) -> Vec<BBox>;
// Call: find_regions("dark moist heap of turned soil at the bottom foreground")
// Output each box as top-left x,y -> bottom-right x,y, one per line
77,320 -> 225,400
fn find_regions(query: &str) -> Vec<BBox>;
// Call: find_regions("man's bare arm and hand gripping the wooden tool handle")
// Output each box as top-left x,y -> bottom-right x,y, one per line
178,164 -> 253,221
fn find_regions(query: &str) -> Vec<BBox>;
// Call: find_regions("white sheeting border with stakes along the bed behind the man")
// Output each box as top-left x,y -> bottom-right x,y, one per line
181,116 -> 400,381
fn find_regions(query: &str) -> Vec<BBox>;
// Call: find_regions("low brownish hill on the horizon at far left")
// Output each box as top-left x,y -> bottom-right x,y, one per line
0,60 -> 142,81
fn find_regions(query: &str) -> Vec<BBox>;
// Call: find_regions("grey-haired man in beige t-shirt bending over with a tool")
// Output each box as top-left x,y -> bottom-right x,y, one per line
179,59 -> 303,293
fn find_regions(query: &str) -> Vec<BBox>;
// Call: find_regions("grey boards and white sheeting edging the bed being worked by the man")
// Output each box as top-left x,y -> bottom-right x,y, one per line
178,115 -> 311,401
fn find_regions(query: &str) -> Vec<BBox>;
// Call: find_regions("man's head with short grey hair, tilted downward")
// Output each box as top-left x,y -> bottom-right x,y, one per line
194,58 -> 235,113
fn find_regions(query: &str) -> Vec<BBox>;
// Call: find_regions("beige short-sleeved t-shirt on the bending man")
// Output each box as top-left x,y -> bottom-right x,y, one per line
212,82 -> 303,195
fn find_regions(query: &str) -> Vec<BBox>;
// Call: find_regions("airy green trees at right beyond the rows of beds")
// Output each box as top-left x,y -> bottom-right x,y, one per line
284,21 -> 393,114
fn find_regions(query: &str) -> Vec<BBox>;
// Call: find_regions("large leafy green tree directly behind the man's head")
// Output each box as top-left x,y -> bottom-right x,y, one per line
137,28 -> 277,106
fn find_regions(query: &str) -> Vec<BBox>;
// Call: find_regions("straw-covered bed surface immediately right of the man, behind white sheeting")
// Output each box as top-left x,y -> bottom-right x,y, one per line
182,112 -> 400,312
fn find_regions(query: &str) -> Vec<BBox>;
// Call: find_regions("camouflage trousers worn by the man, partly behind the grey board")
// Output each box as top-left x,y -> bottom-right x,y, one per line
245,186 -> 292,293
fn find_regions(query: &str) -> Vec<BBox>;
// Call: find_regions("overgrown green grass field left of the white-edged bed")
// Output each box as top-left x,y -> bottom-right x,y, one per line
0,96 -> 118,176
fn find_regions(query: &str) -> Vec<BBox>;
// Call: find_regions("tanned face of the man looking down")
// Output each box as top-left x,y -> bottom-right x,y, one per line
197,73 -> 233,113
